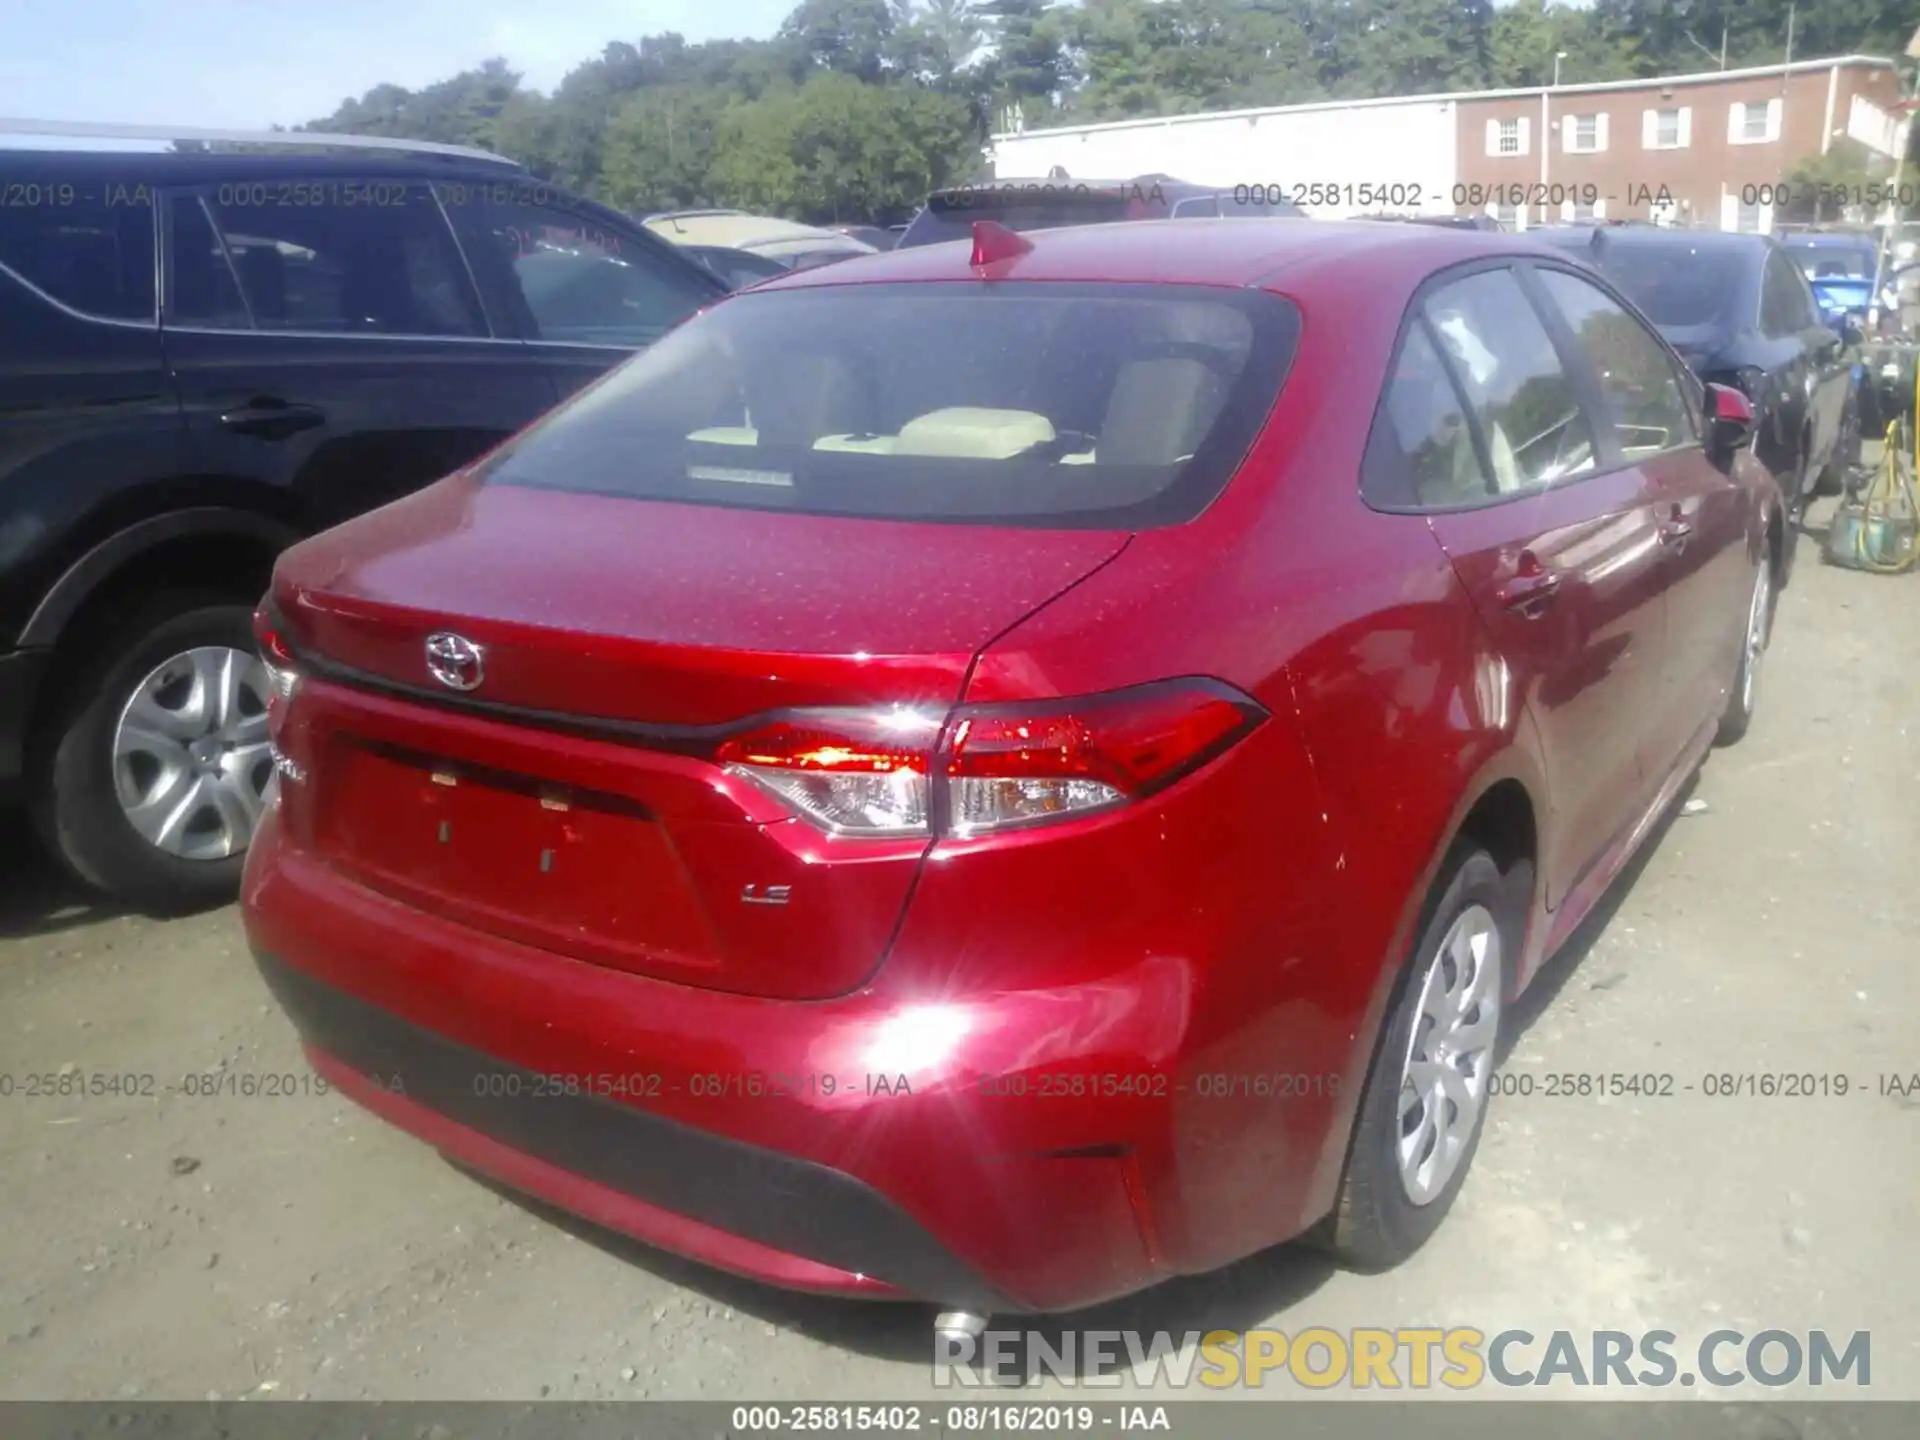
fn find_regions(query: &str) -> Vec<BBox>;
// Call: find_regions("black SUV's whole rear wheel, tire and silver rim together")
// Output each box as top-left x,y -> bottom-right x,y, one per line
35,593 -> 273,914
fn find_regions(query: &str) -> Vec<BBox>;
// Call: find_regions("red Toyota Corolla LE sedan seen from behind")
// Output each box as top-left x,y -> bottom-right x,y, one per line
244,221 -> 1784,1323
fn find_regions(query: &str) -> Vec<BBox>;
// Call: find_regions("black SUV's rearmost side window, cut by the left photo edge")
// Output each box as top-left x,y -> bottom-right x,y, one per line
0,177 -> 154,321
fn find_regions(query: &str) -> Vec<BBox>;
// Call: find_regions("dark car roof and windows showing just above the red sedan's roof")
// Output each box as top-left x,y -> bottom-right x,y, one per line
895,175 -> 1306,250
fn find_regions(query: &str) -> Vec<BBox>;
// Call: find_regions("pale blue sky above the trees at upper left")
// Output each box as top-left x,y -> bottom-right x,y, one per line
0,0 -> 793,129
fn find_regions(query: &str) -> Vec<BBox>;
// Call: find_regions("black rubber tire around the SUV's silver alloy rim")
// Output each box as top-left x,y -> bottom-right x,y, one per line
31,591 -> 270,914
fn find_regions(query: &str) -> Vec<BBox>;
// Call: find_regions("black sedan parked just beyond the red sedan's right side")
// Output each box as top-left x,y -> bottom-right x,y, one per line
1534,225 -> 1860,522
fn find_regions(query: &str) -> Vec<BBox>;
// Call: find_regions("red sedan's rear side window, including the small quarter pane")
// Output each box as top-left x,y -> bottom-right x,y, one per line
1363,271 -> 1597,509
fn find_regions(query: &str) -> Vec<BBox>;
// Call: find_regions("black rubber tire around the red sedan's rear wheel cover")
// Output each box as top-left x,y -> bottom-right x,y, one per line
1313,843 -> 1530,1269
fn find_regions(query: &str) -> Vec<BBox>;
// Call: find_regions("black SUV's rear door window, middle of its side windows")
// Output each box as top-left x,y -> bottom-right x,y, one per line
167,180 -> 486,336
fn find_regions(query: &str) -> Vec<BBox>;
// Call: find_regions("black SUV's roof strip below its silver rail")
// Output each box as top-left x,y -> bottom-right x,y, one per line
0,146 -> 528,184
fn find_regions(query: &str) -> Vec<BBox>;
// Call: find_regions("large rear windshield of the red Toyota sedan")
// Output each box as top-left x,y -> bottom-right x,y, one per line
486,282 -> 1300,530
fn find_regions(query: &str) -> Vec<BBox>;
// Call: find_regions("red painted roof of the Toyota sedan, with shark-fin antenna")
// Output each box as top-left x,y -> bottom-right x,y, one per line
741,219 -> 1540,292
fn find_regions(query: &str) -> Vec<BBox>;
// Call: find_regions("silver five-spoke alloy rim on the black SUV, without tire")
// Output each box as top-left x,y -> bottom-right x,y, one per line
113,645 -> 273,860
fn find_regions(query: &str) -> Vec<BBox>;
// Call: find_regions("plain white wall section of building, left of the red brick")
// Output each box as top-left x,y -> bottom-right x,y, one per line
989,100 -> 1459,219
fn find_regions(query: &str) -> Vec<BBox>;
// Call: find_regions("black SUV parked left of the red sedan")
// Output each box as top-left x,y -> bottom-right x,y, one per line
0,136 -> 726,910
